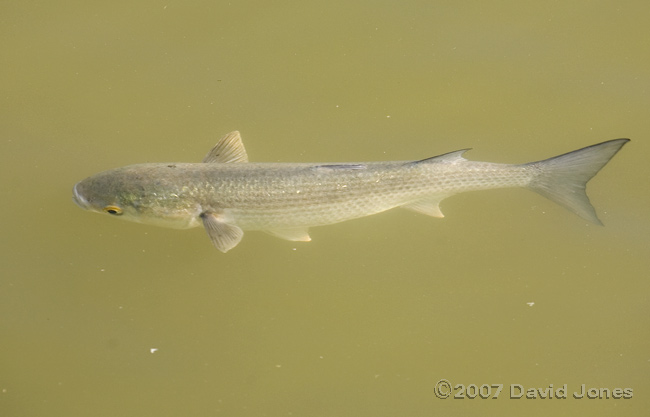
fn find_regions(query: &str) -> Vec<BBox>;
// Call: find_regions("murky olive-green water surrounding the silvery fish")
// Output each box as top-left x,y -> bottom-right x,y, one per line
0,1 -> 650,417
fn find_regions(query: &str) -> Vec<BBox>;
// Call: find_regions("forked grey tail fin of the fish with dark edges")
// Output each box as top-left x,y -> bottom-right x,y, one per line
528,139 -> 630,225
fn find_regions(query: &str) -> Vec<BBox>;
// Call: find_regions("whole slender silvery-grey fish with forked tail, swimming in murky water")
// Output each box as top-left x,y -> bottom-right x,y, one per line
73,131 -> 629,253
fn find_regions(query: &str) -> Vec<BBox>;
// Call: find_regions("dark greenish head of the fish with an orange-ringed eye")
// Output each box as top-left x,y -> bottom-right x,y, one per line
72,164 -> 201,228
